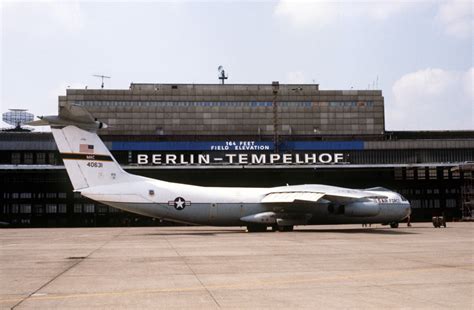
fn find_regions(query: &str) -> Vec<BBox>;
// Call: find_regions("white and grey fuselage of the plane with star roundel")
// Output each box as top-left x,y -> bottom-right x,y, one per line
82,178 -> 410,226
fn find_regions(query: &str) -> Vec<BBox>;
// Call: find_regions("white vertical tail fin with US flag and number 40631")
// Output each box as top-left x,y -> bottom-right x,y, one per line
51,125 -> 139,191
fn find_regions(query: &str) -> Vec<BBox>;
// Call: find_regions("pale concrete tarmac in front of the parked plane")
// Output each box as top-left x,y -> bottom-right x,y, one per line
0,223 -> 474,309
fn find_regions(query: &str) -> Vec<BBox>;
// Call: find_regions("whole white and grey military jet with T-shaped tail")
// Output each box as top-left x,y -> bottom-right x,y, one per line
28,104 -> 411,232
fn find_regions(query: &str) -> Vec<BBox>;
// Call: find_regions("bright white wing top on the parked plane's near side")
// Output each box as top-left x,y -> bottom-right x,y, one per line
261,190 -> 386,204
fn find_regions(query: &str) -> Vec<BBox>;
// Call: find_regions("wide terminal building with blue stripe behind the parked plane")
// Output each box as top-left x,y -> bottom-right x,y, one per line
0,82 -> 474,227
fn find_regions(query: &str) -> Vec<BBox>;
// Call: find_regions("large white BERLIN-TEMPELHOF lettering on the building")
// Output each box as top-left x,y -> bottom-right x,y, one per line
137,153 -> 345,165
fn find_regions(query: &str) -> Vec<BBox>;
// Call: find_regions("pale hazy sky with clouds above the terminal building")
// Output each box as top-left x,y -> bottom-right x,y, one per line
0,0 -> 474,130
